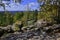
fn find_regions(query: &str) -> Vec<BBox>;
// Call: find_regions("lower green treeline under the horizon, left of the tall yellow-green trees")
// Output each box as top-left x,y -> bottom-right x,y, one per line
0,11 -> 38,26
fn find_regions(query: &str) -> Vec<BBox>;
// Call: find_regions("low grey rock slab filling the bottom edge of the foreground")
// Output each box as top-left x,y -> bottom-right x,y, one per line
1,28 -> 60,40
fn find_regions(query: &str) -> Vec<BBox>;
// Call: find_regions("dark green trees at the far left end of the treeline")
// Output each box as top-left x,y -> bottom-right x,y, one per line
0,12 -> 13,26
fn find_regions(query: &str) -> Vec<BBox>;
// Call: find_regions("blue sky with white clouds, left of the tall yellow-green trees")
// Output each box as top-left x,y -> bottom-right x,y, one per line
0,0 -> 39,11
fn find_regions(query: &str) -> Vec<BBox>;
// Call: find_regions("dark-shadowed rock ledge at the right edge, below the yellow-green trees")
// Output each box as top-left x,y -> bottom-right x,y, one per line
44,24 -> 60,34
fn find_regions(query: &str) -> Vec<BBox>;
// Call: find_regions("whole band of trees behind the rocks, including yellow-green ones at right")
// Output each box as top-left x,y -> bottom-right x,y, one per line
0,5 -> 60,26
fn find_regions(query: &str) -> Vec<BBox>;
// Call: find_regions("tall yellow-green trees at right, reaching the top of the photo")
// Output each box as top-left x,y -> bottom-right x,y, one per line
38,0 -> 60,23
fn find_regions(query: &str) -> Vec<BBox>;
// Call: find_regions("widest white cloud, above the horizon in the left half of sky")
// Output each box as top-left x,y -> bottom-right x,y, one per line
6,4 -> 27,11
